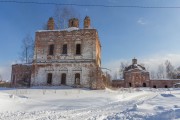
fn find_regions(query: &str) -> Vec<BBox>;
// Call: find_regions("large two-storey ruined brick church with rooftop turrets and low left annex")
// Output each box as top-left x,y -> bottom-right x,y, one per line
11,16 -> 104,89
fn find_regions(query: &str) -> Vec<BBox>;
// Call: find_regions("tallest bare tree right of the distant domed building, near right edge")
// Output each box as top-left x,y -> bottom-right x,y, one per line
165,60 -> 174,79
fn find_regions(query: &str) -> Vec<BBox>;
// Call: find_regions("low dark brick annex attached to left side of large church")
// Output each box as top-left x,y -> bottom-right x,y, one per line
11,64 -> 32,87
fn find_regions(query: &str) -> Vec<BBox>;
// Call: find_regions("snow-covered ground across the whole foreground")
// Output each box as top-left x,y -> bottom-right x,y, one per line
0,86 -> 180,120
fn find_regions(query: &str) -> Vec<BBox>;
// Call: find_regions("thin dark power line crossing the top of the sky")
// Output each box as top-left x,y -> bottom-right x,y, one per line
0,0 -> 180,9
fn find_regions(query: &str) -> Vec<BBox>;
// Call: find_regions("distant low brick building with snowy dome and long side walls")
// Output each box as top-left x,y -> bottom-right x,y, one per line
112,58 -> 180,88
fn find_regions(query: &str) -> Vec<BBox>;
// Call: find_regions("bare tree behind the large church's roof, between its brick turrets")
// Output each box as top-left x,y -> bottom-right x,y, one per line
54,6 -> 81,29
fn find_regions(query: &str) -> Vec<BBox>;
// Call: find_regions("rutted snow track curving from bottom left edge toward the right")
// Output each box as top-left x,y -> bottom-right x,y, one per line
0,92 -> 157,120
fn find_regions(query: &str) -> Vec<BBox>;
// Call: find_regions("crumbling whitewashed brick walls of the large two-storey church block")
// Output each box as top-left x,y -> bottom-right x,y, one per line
31,21 -> 104,89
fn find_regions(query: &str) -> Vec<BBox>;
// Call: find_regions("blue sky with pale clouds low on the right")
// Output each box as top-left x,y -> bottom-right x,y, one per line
0,0 -> 180,79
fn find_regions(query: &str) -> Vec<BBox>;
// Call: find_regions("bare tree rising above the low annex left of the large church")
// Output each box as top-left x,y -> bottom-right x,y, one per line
19,35 -> 34,63
